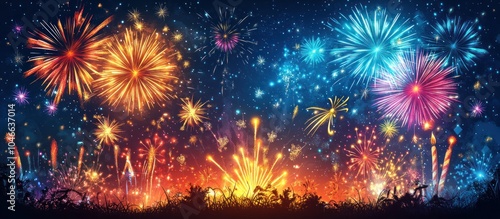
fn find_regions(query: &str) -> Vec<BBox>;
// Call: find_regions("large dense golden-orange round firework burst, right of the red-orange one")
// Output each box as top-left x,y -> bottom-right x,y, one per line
96,29 -> 176,112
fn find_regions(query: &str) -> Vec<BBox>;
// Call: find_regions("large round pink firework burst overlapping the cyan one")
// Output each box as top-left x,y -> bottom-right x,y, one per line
373,51 -> 456,128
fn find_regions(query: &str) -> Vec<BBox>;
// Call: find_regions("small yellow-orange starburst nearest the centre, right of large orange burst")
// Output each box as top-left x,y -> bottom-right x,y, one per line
179,98 -> 208,130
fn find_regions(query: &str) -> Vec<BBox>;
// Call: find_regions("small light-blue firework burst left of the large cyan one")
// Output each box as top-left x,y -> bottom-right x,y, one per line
300,37 -> 325,65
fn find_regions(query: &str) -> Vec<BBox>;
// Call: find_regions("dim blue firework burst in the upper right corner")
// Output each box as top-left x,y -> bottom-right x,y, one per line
428,17 -> 487,72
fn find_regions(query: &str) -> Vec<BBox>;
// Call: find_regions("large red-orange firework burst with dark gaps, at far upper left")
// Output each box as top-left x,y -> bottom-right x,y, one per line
24,9 -> 111,104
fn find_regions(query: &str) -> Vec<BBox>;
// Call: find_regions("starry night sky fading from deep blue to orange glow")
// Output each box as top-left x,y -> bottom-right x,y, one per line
0,0 -> 500,202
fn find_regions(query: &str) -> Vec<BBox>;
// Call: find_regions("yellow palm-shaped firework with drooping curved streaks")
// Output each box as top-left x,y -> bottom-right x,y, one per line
306,97 -> 349,135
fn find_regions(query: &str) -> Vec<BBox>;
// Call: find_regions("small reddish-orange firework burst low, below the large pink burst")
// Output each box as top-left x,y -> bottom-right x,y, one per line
346,127 -> 382,178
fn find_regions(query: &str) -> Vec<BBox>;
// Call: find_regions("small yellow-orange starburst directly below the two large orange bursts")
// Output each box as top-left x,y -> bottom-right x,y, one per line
94,117 -> 123,145
